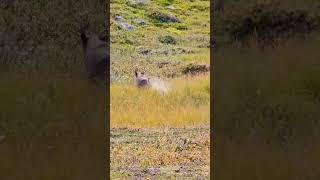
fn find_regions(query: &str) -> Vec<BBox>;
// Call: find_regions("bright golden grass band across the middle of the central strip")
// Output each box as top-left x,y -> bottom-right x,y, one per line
110,75 -> 210,128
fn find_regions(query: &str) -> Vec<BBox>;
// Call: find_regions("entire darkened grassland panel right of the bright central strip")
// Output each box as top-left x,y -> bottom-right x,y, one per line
213,0 -> 320,180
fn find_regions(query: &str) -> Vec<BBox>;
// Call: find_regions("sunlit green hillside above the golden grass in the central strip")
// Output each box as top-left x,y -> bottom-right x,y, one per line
110,0 -> 210,83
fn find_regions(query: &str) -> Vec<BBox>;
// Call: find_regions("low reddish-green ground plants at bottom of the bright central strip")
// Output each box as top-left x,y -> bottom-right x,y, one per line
111,128 -> 210,179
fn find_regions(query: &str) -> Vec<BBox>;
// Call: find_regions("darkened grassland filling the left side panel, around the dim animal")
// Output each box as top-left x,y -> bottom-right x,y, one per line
0,0 -> 106,180
